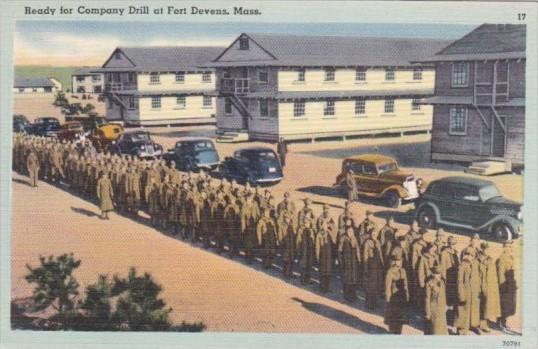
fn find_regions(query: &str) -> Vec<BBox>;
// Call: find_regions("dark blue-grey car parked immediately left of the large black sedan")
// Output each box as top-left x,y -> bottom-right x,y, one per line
163,137 -> 219,172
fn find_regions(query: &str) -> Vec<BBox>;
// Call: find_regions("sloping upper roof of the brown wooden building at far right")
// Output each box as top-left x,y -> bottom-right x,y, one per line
416,24 -> 527,62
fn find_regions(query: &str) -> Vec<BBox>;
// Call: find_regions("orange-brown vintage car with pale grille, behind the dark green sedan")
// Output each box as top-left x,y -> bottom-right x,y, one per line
335,154 -> 422,208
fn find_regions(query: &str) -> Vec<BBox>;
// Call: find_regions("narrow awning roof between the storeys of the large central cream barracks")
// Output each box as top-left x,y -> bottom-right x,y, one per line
242,89 -> 433,99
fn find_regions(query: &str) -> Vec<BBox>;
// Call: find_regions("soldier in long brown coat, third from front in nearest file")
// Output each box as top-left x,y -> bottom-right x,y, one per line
338,219 -> 361,302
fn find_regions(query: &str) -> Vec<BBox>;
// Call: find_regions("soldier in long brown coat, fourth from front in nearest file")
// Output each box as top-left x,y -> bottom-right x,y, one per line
315,219 -> 334,293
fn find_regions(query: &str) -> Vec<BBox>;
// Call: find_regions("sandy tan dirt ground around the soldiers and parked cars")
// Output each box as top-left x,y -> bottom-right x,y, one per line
12,126 -> 523,334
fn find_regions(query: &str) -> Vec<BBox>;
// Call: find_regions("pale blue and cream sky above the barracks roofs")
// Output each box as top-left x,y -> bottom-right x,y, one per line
15,21 -> 475,66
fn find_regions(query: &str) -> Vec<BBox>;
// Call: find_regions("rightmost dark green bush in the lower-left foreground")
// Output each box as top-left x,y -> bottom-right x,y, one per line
112,268 -> 172,331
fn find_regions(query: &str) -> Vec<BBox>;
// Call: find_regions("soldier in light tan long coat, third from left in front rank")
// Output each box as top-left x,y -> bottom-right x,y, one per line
454,250 -> 480,335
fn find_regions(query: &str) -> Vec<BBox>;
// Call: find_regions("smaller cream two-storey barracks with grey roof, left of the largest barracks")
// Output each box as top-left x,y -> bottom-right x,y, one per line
96,47 -> 223,125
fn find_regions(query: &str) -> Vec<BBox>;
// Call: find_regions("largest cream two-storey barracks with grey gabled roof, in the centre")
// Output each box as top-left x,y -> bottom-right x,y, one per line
208,34 -> 448,141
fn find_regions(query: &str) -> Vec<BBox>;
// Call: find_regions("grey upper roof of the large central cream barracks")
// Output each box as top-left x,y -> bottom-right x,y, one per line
212,34 -> 450,66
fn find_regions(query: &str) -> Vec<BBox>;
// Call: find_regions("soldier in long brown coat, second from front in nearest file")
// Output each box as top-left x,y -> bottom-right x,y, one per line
362,228 -> 384,309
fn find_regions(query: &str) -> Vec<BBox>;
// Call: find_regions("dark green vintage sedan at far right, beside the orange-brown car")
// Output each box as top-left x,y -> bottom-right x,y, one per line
416,176 -> 523,240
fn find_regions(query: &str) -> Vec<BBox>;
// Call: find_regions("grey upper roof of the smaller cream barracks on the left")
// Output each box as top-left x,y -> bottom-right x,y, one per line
97,46 -> 224,71
